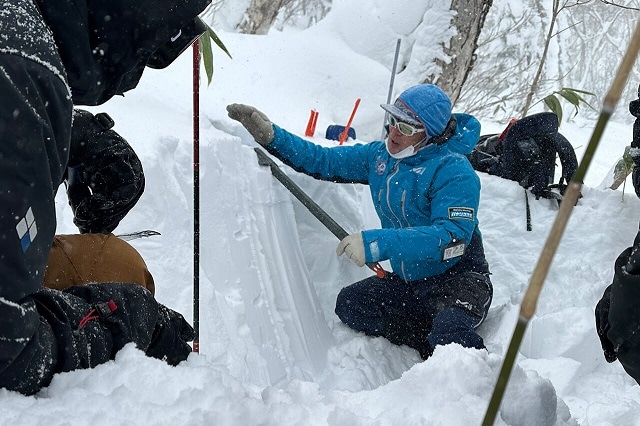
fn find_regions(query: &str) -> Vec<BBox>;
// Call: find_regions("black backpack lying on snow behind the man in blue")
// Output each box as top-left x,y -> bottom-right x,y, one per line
468,112 -> 578,201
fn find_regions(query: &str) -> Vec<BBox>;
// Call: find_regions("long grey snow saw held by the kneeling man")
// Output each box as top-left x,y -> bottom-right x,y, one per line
255,148 -> 386,278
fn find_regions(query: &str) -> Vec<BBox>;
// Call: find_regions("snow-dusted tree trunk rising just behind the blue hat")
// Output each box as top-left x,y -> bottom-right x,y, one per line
425,0 -> 493,104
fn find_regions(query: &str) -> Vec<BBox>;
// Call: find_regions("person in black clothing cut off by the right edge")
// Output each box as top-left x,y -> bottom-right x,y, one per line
595,82 -> 640,384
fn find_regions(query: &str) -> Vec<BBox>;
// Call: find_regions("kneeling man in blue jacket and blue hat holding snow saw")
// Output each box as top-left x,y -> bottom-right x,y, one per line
227,84 -> 493,359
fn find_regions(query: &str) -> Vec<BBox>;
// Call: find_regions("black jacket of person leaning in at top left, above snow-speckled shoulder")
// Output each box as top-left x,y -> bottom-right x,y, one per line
36,0 -> 211,105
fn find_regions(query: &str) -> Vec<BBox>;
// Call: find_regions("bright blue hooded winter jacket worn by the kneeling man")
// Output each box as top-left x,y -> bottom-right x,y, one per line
267,114 -> 488,281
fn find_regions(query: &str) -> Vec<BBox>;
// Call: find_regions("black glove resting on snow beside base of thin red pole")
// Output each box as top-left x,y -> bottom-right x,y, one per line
146,305 -> 196,365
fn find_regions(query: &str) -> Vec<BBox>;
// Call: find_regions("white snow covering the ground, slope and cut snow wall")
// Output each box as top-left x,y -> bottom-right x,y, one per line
0,0 -> 640,425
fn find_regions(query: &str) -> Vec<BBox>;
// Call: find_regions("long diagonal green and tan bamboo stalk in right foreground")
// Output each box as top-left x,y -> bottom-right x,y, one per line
482,20 -> 640,426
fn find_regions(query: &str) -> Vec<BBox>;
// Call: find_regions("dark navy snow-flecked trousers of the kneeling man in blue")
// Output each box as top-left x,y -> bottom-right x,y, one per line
335,272 -> 493,358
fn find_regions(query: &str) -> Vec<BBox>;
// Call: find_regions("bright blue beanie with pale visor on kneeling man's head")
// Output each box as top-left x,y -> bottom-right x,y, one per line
380,84 -> 451,137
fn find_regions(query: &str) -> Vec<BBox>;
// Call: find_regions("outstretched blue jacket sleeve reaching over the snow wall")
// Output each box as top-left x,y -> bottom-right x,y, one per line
266,124 -> 377,184
